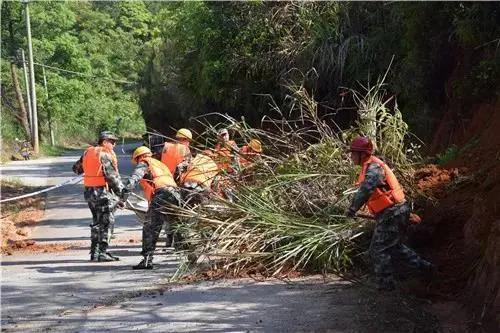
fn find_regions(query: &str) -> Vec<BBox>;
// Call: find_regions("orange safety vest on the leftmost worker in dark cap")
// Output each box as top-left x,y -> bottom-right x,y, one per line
82,146 -> 118,187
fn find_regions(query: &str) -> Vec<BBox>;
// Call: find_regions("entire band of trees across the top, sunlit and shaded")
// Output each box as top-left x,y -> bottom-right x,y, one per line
1,1 -> 500,149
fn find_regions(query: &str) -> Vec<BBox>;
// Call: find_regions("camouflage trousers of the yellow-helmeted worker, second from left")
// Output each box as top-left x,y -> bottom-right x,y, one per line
142,187 -> 181,256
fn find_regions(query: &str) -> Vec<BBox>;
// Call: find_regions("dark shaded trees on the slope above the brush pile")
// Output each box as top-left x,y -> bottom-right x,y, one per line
140,1 -> 500,143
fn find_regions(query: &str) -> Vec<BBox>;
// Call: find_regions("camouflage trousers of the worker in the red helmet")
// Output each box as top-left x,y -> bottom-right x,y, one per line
369,203 -> 429,287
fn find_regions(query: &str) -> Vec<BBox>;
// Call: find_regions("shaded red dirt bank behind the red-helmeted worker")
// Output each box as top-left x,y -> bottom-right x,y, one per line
416,100 -> 500,327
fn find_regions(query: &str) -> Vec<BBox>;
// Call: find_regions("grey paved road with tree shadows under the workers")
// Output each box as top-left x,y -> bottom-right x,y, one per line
0,146 -> 436,332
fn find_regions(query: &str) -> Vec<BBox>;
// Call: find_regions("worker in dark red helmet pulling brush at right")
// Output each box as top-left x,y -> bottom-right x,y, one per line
346,137 -> 433,290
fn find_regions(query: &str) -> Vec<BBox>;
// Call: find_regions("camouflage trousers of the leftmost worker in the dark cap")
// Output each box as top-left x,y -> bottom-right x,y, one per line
84,187 -> 118,253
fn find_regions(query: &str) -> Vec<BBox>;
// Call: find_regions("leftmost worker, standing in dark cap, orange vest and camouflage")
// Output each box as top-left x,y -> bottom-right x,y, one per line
73,131 -> 123,262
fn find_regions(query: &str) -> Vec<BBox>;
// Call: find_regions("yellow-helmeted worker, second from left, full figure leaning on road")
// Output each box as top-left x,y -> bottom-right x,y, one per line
122,146 -> 181,269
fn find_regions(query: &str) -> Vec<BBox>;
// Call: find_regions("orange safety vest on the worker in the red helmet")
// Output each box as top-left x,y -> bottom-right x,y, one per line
357,156 -> 405,215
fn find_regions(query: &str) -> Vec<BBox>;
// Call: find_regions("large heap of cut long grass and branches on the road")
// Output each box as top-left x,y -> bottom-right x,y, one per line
173,83 -> 422,276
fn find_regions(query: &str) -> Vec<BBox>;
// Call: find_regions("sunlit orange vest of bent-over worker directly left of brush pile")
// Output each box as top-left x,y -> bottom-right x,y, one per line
181,154 -> 219,188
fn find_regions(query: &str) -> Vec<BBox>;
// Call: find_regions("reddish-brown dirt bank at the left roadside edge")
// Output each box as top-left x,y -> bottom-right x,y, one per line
0,181 -> 69,255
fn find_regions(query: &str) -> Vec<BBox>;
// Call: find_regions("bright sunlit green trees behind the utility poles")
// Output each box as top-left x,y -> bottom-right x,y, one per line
2,1 -> 148,144
